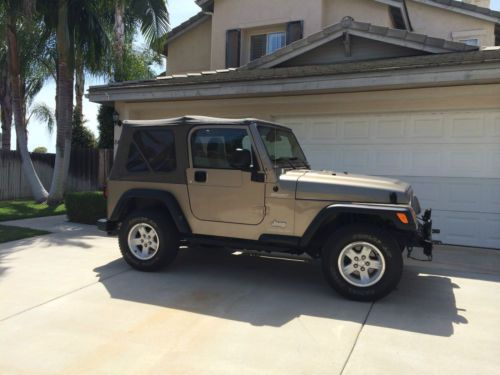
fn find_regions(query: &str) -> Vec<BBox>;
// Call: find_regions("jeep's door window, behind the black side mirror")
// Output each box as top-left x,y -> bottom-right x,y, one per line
191,128 -> 253,169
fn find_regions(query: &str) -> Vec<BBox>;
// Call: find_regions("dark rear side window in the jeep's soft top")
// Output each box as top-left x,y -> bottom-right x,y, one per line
127,129 -> 176,172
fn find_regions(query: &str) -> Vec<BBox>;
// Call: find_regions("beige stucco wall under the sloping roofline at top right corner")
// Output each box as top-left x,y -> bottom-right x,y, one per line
406,0 -> 495,46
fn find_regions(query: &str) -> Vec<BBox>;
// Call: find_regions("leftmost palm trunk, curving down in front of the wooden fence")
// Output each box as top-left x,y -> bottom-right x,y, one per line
2,0 -> 48,202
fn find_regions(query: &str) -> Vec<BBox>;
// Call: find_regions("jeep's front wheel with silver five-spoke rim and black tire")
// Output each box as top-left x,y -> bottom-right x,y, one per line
322,225 -> 403,301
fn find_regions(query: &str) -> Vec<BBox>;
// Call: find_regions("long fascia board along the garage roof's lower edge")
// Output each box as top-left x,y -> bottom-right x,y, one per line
88,59 -> 500,104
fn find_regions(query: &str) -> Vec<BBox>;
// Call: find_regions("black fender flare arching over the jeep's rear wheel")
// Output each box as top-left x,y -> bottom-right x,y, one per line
110,189 -> 191,234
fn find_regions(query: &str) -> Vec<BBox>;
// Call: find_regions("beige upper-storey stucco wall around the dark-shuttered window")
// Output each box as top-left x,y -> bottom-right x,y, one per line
212,0 -> 323,69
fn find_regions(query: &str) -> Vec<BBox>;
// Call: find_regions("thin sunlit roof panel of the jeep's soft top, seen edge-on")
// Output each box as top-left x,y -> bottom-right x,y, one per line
123,116 -> 288,129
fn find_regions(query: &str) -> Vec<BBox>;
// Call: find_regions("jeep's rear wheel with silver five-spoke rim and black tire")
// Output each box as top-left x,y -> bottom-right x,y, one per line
119,210 -> 179,271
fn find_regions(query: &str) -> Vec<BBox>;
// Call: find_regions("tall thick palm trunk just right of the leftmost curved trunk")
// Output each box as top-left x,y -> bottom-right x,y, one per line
48,0 -> 74,205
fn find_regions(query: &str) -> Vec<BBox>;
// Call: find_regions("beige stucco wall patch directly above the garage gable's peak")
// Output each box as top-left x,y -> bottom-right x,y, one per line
323,0 -> 392,27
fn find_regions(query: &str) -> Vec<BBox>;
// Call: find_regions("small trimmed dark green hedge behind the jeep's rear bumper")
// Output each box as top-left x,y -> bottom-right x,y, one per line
64,191 -> 106,225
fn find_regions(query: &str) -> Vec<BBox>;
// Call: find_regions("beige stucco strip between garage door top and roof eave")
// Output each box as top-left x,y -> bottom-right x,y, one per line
116,84 -> 500,123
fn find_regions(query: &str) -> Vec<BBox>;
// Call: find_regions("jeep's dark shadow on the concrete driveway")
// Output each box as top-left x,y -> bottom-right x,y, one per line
94,249 -> 467,337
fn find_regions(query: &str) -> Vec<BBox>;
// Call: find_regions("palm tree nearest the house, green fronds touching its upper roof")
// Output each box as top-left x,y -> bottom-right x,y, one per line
113,0 -> 170,81
